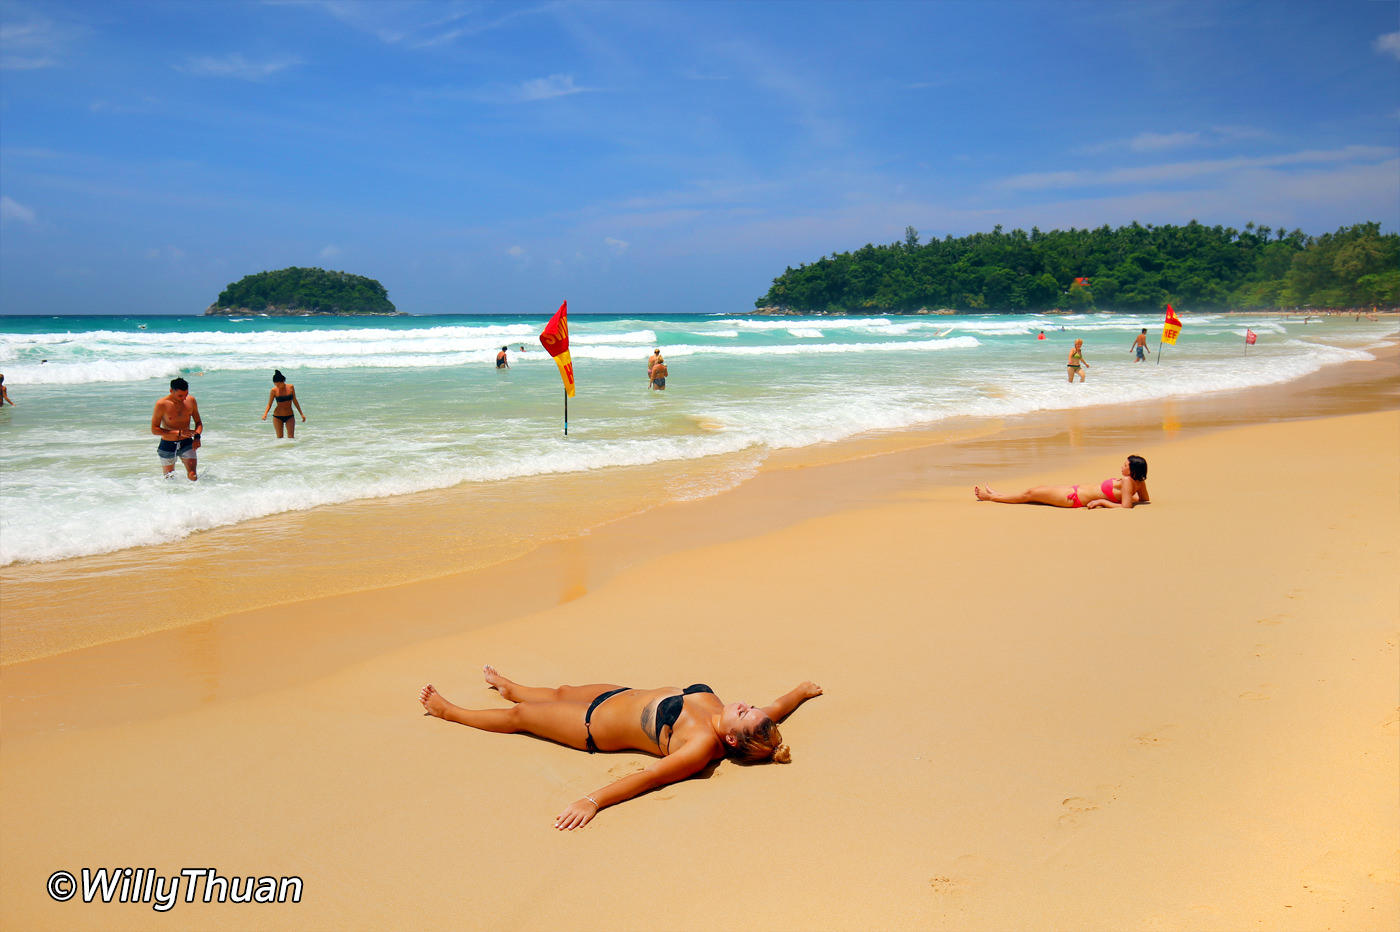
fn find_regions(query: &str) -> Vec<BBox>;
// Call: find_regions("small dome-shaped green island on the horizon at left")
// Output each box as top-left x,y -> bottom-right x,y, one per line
204,267 -> 409,318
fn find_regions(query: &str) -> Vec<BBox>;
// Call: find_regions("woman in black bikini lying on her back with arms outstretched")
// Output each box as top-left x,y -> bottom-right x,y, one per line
419,666 -> 822,830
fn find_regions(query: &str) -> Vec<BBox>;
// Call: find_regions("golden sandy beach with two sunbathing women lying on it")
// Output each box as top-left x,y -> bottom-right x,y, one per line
0,353 -> 1400,931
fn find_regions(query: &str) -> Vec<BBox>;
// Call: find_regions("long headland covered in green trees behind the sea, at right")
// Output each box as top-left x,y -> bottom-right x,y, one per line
755,220 -> 1400,313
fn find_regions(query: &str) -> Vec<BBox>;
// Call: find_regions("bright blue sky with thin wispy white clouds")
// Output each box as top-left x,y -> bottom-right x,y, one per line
0,0 -> 1400,313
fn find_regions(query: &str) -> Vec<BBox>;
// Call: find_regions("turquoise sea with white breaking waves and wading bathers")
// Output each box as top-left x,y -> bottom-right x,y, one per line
0,309 -> 1397,565
